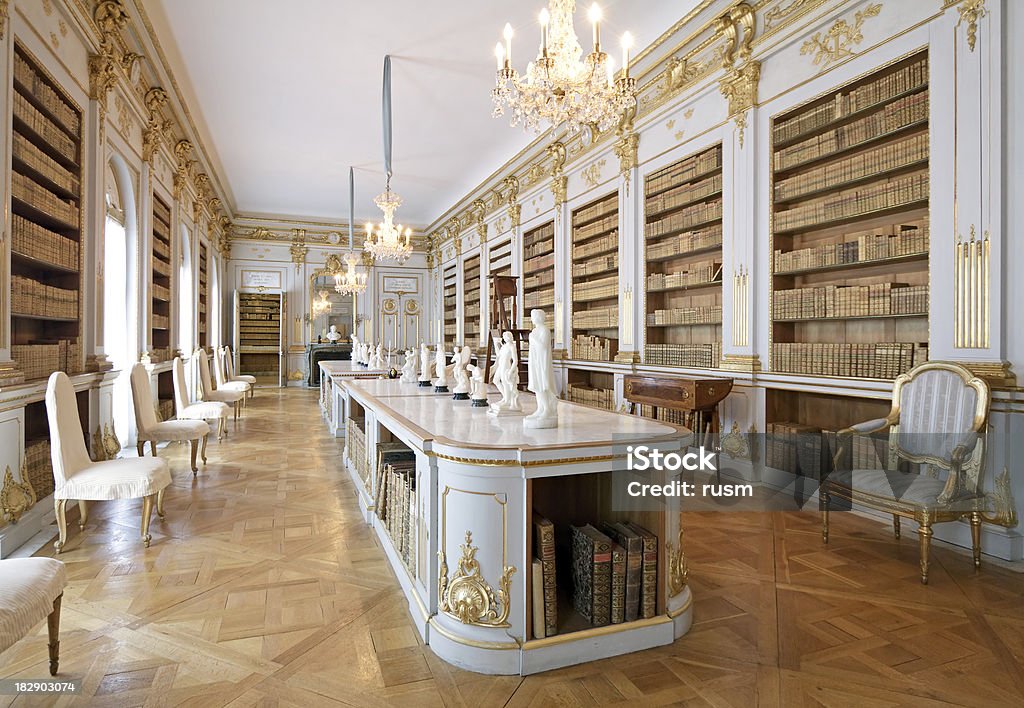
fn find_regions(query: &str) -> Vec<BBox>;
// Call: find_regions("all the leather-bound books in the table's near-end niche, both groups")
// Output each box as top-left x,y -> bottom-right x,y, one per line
531,513 -> 657,638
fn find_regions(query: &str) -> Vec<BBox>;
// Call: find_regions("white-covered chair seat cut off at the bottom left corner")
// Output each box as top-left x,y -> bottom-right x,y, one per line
0,558 -> 68,676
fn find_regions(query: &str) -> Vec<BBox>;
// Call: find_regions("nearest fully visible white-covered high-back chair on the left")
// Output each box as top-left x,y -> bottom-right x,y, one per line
46,371 -> 171,553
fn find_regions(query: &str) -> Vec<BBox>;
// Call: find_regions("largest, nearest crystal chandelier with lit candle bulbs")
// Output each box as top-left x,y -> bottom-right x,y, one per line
490,0 -> 637,133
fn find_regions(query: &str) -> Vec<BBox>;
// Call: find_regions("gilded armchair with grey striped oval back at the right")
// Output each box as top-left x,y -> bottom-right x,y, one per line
821,362 -> 989,584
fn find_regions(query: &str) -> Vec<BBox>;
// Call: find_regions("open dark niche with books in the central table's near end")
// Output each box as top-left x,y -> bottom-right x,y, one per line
528,472 -> 666,639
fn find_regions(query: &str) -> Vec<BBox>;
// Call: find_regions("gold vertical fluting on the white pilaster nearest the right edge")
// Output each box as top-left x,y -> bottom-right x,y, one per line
953,223 -> 990,349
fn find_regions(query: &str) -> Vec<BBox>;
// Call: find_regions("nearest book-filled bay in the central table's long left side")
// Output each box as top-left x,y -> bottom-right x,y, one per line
374,443 -> 418,578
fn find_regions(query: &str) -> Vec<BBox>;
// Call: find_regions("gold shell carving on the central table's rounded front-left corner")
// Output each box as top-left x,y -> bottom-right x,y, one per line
437,530 -> 515,628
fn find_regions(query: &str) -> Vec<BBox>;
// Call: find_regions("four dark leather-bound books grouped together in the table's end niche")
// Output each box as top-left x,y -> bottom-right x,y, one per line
571,522 -> 657,627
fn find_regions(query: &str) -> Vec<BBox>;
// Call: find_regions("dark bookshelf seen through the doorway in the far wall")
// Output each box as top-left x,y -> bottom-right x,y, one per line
237,292 -> 282,384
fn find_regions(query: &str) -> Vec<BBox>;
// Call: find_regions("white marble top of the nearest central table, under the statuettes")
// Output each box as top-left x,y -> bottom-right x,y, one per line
341,379 -> 689,451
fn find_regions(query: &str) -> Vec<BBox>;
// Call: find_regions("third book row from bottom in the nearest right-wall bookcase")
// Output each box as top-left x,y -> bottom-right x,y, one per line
775,219 -> 929,275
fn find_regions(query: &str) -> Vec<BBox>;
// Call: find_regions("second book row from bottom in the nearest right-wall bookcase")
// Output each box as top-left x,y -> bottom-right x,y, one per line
772,283 -> 928,320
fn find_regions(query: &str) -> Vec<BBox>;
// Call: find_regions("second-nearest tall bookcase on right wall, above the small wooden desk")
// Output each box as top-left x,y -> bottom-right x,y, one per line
644,144 -> 722,369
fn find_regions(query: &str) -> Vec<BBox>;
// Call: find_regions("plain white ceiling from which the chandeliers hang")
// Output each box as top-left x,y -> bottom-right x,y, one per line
141,0 -> 695,227
